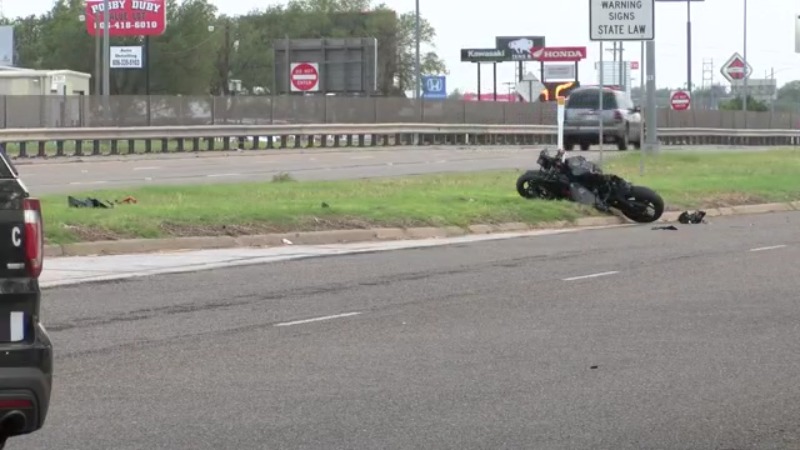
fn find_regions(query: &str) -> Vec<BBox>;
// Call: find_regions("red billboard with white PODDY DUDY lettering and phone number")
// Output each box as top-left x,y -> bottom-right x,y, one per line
85,0 -> 167,36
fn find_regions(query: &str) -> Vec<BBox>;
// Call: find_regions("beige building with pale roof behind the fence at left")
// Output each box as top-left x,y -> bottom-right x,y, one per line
0,66 -> 92,128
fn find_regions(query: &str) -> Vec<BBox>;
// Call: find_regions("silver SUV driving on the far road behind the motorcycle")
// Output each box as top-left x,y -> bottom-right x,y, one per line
564,87 -> 644,151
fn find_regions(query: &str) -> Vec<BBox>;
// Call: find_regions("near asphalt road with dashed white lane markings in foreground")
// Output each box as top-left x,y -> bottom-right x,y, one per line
9,213 -> 800,450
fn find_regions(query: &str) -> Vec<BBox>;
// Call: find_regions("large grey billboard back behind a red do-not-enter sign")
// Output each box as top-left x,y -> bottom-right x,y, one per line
272,38 -> 380,94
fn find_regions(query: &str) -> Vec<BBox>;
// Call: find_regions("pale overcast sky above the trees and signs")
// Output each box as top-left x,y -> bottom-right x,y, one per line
0,0 -> 800,92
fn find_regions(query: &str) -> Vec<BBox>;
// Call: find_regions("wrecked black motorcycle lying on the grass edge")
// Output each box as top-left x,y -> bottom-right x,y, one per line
517,149 -> 664,223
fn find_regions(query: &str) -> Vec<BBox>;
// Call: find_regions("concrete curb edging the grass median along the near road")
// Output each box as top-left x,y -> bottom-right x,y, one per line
45,201 -> 800,257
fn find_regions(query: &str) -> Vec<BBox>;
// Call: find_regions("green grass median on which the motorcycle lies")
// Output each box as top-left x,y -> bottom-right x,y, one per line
39,150 -> 800,243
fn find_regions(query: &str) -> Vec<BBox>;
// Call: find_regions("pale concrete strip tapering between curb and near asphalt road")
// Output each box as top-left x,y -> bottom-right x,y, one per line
40,229 -> 600,288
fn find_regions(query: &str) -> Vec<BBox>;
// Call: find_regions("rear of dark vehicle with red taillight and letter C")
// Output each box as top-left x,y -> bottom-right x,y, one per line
0,151 -> 53,449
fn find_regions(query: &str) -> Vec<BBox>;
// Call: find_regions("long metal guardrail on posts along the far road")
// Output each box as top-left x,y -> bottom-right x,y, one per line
0,123 -> 800,158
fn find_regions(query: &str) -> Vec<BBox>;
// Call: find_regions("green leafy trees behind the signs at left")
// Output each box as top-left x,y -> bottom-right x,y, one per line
3,0 -> 447,96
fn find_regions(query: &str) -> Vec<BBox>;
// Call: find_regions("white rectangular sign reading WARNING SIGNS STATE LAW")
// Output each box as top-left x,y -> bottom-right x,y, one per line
589,0 -> 656,41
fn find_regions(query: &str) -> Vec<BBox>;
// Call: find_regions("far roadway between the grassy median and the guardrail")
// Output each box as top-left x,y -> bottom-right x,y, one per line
12,146 -> 776,194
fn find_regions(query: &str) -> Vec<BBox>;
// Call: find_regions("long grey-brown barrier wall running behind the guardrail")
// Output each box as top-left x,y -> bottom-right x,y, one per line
0,96 -> 800,129
